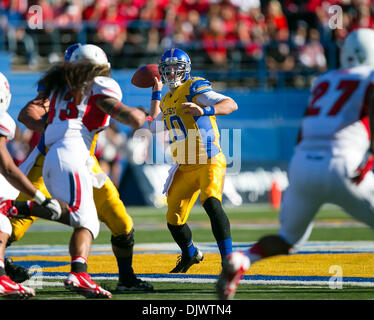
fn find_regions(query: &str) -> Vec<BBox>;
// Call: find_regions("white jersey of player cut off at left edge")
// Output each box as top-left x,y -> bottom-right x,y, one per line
0,111 -> 19,199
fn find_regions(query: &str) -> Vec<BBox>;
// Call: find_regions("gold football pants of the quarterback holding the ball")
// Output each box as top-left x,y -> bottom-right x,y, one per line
166,152 -> 226,225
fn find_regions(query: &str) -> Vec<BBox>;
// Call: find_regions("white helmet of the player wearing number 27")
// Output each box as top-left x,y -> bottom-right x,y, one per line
340,28 -> 374,68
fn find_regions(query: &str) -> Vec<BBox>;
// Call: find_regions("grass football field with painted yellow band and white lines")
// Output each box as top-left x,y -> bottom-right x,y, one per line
4,205 -> 374,308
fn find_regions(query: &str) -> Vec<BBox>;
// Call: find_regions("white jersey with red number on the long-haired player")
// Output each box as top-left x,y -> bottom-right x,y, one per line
45,77 -> 122,149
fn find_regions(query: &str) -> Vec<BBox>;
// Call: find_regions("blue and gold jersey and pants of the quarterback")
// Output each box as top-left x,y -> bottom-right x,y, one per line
160,78 -> 226,225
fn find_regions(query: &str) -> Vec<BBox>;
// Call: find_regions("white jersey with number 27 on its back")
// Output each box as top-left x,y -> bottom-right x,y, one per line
298,66 -> 374,154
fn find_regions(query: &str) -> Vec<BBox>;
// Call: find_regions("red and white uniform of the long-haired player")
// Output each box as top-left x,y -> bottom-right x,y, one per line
43,77 -> 122,238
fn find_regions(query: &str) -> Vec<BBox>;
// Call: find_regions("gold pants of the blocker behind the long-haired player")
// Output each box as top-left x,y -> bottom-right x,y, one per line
10,154 -> 134,241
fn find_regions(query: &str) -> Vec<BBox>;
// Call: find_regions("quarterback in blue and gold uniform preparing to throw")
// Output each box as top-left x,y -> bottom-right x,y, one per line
150,48 -> 238,273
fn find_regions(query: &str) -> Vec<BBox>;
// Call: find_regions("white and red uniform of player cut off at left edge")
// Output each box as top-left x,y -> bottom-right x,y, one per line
0,111 -> 19,236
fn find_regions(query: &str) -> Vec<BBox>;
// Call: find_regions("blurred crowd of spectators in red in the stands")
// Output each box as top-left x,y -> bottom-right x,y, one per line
0,0 -> 373,72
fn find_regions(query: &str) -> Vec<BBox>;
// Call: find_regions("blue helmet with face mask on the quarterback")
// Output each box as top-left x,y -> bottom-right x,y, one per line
158,48 -> 191,88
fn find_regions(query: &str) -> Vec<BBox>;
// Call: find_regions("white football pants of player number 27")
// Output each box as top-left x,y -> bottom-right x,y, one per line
279,150 -> 374,246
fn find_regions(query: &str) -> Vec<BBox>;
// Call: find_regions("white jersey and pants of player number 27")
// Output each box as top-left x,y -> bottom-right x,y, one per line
280,66 -> 374,245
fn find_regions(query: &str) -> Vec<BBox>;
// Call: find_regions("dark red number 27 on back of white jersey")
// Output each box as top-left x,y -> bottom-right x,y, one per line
306,80 -> 360,116
